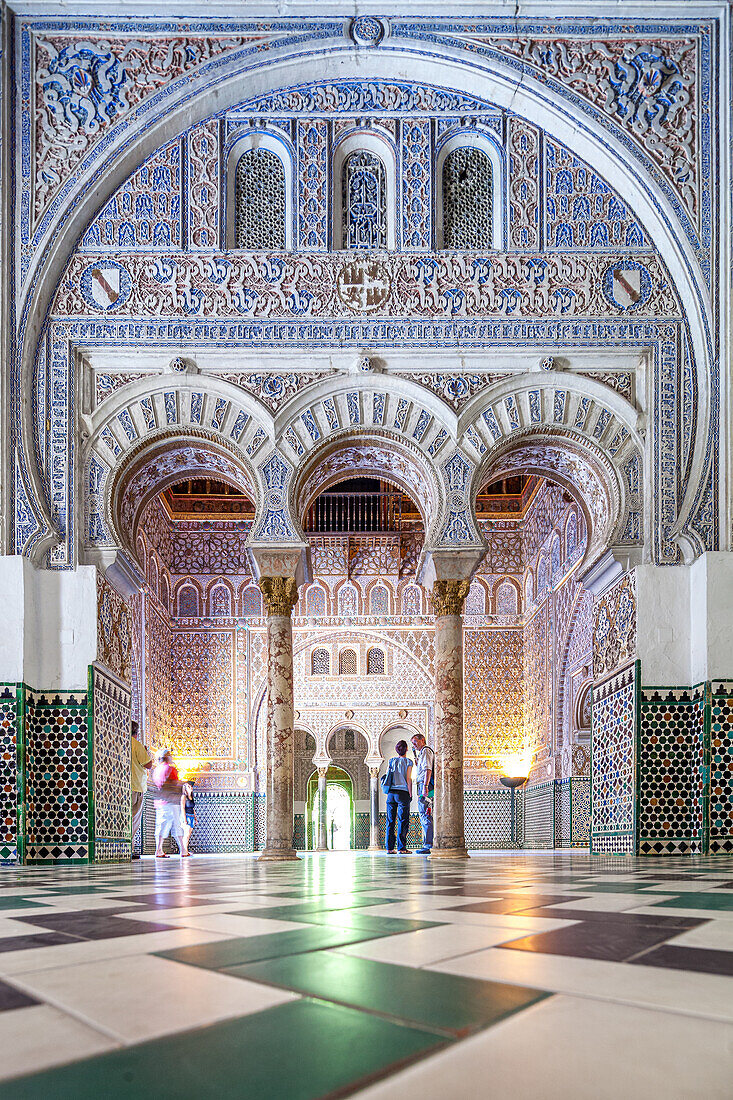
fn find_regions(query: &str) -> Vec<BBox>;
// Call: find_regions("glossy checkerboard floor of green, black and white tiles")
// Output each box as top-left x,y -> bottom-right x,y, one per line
0,853 -> 733,1100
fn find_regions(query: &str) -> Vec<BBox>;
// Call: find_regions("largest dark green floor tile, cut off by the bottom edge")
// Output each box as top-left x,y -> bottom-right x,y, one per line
0,1001 -> 445,1100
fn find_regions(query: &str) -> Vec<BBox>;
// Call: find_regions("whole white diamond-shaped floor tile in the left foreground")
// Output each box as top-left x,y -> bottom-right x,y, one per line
13,956 -> 297,1043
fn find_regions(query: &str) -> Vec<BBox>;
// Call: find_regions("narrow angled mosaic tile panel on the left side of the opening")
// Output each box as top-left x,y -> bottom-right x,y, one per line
89,666 -> 131,859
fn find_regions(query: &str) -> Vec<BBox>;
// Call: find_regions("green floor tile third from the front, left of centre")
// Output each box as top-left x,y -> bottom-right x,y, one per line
154,925 -> 389,970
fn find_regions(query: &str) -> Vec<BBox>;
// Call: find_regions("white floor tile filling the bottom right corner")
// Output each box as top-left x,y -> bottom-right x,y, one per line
358,997 -> 733,1100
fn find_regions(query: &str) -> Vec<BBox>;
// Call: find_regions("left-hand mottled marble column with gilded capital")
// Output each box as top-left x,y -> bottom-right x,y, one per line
259,576 -> 298,860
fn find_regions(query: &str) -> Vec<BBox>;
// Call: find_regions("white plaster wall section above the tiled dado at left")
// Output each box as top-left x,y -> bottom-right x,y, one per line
0,557 -> 97,691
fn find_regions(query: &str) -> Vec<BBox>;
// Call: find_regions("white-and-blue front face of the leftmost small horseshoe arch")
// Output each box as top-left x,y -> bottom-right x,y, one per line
77,378 -> 264,547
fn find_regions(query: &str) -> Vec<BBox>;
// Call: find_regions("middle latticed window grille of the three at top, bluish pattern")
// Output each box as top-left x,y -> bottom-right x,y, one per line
341,152 -> 386,249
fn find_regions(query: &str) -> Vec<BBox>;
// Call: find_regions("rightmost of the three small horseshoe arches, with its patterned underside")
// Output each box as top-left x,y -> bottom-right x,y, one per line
459,371 -> 638,565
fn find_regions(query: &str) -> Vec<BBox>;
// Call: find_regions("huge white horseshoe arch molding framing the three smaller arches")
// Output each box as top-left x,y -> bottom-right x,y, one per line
17,37 -> 708,552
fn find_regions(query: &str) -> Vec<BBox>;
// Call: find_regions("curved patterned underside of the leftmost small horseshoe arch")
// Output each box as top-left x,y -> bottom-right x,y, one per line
94,428 -> 256,560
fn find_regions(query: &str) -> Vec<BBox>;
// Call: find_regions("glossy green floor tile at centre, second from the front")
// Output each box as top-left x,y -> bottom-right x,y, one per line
232,952 -> 549,1037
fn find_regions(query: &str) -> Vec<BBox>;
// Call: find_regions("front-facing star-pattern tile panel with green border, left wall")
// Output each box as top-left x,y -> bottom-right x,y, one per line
25,691 -> 89,862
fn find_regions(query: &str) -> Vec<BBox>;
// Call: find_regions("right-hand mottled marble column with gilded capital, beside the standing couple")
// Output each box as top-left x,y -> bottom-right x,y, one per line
431,580 -> 469,859
